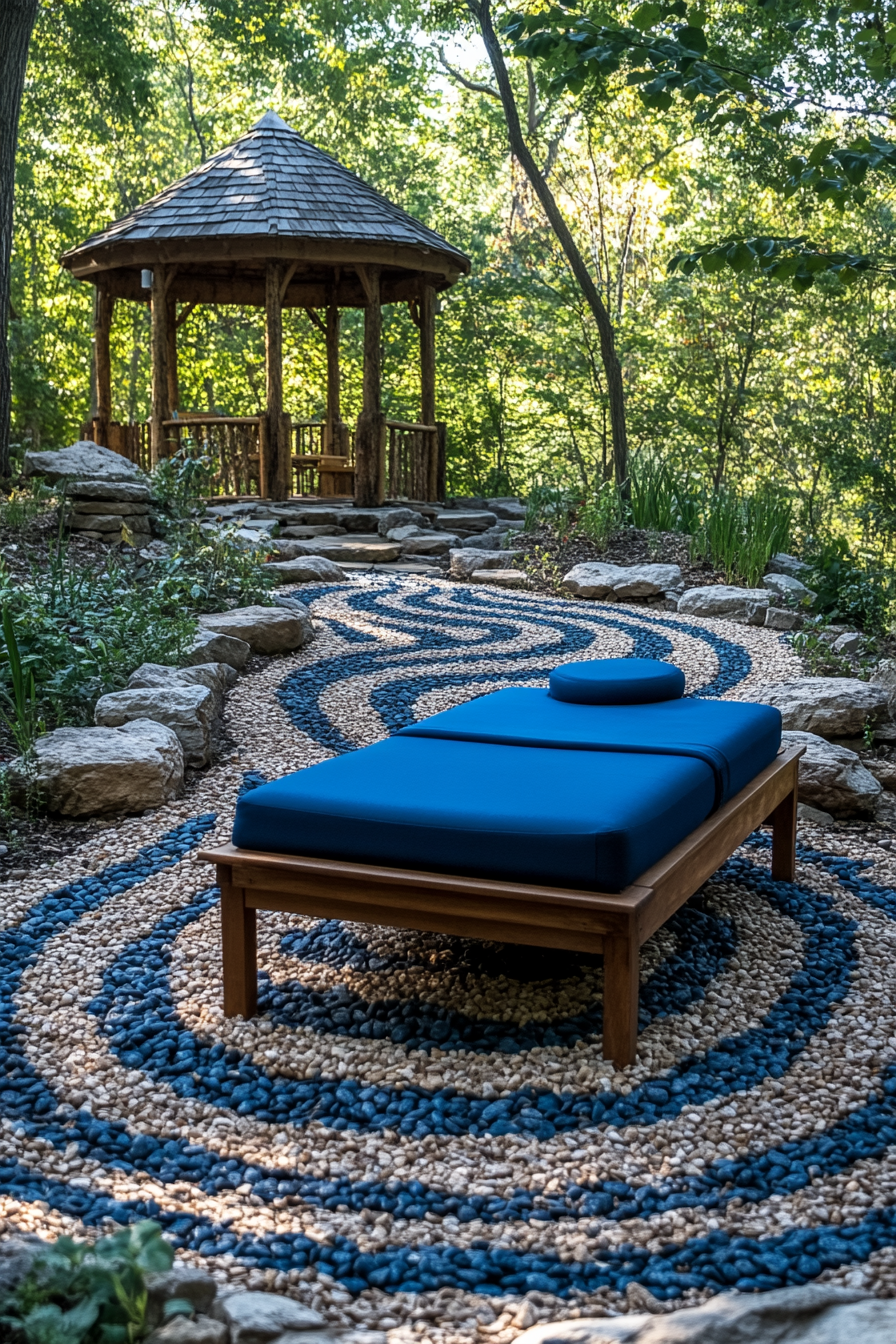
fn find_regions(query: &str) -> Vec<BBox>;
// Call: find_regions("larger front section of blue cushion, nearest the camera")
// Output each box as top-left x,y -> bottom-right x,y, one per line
234,736 -> 715,891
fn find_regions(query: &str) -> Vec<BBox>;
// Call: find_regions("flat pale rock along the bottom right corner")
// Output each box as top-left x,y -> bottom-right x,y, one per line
516,1284 -> 896,1344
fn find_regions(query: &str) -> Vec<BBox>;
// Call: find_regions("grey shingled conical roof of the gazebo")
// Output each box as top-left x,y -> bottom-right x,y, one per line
62,112 -> 470,306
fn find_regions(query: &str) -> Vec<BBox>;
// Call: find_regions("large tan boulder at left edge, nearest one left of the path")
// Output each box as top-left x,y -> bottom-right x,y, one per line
9,719 -> 184,817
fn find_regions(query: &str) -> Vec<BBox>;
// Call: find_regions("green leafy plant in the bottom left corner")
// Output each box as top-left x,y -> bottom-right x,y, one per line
0,1222 -> 173,1344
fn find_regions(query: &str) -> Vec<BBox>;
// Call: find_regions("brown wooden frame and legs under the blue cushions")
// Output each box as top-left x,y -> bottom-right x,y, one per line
199,747 -> 805,1064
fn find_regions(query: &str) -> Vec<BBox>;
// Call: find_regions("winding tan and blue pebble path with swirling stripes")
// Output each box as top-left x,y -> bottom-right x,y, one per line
0,575 -> 896,1344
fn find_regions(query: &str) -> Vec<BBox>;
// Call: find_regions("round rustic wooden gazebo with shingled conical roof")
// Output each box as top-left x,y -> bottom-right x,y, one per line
62,112 -> 470,505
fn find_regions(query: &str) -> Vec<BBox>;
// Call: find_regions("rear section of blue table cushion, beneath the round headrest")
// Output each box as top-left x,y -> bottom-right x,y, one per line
399,688 -> 780,806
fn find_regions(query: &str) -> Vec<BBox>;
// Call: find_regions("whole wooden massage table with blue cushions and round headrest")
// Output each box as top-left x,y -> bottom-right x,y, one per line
200,659 -> 802,1066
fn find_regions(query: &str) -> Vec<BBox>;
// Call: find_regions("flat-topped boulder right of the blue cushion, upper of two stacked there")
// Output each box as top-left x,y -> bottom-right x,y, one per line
751,676 -> 888,738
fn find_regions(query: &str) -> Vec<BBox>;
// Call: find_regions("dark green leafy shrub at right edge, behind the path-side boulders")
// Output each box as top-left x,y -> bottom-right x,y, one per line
805,538 -> 896,634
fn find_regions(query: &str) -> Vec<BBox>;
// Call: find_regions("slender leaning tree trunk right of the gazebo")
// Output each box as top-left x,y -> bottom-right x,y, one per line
467,0 -> 630,499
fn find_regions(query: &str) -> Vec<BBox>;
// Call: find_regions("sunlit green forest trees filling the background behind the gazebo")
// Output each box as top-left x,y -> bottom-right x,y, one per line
9,0 -> 896,550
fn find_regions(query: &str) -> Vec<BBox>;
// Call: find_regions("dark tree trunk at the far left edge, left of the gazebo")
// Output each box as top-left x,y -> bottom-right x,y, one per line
0,0 -> 38,477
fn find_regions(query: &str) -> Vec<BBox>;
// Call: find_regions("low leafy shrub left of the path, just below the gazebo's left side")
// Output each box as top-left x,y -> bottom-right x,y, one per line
148,524 -> 277,612
